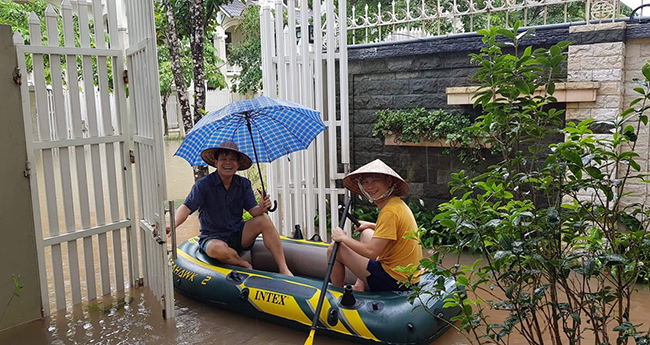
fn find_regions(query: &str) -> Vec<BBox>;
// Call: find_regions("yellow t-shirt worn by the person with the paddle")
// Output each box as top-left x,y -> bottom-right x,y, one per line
373,197 -> 422,283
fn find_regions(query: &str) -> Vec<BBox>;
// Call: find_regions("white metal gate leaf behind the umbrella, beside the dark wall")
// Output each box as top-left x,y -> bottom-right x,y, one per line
260,0 -> 350,239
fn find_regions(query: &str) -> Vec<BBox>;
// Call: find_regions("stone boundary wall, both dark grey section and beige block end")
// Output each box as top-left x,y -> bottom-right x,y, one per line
348,23 -> 650,208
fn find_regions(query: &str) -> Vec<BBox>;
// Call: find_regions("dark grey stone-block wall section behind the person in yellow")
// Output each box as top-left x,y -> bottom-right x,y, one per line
349,51 -> 476,204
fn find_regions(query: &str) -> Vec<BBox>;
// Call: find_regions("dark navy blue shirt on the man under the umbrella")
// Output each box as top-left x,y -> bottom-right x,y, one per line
184,171 -> 257,242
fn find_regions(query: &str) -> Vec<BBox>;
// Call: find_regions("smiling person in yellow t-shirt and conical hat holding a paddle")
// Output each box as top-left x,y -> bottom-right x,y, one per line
328,159 -> 422,291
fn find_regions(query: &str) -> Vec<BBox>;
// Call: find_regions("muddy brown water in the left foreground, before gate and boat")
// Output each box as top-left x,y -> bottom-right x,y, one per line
0,289 -> 340,345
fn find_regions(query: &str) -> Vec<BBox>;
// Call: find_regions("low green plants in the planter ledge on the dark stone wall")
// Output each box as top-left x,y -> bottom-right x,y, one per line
372,108 -> 471,145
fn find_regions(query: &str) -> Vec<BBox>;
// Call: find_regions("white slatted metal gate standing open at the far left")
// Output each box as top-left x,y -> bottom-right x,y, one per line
14,0 -> 173,316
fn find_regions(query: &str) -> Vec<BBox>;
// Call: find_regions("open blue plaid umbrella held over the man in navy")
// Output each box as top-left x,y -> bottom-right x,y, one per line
174,97 -> 325,209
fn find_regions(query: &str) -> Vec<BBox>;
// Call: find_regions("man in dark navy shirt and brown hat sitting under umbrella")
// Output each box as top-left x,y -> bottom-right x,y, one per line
167,140 -> 293,276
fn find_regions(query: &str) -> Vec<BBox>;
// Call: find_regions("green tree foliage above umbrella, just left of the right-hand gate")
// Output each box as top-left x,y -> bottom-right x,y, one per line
228,5 -> 262,94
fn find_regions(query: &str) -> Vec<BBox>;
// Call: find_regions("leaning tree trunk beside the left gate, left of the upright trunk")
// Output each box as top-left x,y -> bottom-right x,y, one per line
163,0 -> 192,133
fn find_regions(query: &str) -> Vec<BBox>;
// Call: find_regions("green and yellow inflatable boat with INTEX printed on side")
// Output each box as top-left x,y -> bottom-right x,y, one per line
172,237 -> 460,344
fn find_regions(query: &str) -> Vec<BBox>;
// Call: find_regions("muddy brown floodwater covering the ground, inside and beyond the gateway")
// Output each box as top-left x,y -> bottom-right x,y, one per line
0,141 -> 650,345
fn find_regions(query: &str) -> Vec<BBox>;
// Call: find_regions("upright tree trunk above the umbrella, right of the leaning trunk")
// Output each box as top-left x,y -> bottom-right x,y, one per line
190,0 -> 208,180
